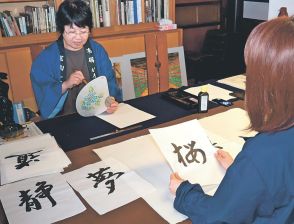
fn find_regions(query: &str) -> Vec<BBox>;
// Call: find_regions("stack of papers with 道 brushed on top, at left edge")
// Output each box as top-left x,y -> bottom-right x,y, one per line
0,134 -> 71,185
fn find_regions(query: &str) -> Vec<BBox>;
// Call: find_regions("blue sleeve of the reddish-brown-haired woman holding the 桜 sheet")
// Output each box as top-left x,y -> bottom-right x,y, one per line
174,153 -> 274,223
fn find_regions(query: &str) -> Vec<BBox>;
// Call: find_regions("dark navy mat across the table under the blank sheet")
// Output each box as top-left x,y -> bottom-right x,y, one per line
36,91 -> 217,151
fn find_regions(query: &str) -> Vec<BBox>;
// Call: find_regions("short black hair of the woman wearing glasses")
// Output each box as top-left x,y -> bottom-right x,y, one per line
56,0 -> 93,33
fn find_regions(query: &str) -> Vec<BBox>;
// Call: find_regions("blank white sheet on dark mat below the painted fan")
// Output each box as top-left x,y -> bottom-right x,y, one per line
97,103 -> 155,128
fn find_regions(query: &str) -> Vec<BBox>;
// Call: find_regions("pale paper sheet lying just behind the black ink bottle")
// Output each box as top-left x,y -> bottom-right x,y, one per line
185,84 -> 234,100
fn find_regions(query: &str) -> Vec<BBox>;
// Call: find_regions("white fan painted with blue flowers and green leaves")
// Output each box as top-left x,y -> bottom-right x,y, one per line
76,76 -> 109,117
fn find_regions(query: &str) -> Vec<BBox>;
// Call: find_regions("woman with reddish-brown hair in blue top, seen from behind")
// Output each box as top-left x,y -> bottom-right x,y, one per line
170,17 -> 294,224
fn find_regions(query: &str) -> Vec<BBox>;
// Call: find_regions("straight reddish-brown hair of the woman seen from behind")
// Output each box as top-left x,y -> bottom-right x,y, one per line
245,17 -> 294,132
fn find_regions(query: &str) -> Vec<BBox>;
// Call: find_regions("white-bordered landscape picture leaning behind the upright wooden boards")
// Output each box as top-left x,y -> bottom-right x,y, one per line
122,47 -> 187,100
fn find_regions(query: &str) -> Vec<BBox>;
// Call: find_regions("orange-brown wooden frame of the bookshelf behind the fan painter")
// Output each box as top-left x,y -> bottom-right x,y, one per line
0,0 -> 183,111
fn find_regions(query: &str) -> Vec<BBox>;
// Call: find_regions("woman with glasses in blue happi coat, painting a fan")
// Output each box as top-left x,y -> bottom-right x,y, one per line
31,0 -> 121,118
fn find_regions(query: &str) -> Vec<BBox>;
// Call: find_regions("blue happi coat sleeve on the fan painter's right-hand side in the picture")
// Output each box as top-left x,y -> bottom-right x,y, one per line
91,41 -> 122,101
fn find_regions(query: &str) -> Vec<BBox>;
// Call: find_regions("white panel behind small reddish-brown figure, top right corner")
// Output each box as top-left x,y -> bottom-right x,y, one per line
268,0 -> 294,19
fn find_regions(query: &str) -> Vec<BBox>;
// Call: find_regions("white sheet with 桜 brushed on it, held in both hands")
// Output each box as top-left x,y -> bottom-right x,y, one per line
149,120 -> 225,185
